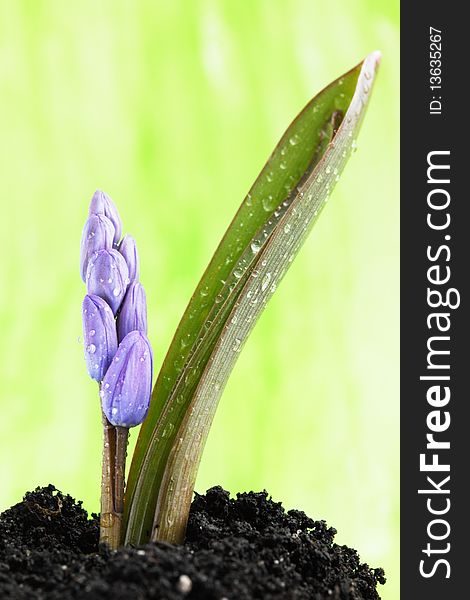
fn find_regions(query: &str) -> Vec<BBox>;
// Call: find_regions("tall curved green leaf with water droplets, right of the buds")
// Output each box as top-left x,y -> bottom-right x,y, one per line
125,53 -> 379,544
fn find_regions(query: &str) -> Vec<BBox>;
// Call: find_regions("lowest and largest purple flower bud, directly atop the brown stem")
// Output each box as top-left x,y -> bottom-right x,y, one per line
100,331 -> 153,427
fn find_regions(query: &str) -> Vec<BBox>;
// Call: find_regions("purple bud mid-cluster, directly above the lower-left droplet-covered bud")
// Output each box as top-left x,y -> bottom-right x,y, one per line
86,250 -> 129,314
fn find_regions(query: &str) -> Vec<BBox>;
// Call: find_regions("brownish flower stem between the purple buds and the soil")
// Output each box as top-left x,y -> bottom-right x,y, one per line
100,413 -> 129,550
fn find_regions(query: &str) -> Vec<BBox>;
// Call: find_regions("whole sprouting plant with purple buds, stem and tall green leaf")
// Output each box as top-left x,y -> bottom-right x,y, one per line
81,52 -> 380,548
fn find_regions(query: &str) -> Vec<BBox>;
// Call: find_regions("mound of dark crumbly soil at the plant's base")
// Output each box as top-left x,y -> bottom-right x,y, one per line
0,485 -> 385,600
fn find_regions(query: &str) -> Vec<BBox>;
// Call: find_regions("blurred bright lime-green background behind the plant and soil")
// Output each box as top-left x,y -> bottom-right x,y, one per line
0,0 -> 399,600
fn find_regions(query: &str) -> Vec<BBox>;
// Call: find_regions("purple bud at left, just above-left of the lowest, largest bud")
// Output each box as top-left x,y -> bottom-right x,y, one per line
82,296 -> 118,381
